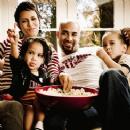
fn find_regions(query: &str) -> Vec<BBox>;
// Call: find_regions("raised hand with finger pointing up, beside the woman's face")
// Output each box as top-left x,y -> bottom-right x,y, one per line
7,24 -> 19,44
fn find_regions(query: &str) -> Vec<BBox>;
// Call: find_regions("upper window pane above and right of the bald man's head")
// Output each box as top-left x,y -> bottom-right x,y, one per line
76,0 -> 113,28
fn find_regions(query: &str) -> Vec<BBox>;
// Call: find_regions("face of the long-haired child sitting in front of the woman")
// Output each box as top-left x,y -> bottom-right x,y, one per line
25,42 -> 44,73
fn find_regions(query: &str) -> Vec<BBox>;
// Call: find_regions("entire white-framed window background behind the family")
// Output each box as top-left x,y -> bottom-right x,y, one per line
0,0 -> 130,47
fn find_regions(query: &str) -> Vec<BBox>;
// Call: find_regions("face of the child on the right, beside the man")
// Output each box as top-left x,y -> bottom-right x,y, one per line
102,33 -> 126,59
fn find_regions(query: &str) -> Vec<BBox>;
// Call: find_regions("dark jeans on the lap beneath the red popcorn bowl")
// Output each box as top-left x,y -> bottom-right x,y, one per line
44,107 -> 101,130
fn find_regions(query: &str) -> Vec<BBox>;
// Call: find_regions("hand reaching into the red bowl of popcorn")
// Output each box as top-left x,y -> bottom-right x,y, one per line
59,72 -> 72,92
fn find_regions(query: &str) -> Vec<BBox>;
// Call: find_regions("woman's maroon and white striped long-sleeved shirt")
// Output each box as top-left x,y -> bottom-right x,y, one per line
0,40 -> 59,90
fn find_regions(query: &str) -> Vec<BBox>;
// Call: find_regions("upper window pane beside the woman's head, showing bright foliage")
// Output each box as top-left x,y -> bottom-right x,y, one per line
32,0 -> 56,30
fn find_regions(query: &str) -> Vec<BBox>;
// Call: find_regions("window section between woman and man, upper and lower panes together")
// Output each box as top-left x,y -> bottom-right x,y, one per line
32,0 -> 57,49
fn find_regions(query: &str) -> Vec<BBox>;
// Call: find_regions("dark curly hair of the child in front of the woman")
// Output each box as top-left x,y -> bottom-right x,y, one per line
20,37 -> 52,65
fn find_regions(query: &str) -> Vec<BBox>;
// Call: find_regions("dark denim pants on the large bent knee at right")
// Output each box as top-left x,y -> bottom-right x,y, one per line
95,70 -> 130,130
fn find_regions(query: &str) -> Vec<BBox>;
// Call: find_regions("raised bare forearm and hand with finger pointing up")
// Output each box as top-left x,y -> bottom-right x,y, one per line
7,25 -> 19,58
